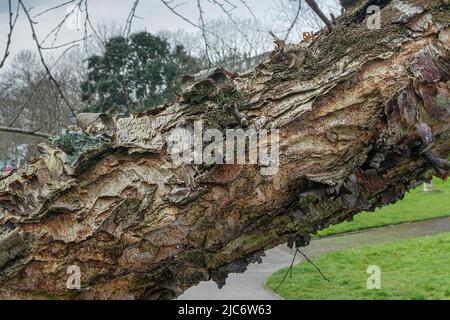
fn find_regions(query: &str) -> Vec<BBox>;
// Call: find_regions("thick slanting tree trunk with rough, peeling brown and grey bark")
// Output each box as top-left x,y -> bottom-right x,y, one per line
0,1 -> 450,299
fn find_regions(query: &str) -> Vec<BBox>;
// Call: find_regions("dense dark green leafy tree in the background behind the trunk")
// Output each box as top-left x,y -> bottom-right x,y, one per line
81,32 -> 186,112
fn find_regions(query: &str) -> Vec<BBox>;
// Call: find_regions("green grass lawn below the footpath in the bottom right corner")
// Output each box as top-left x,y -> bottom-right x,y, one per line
267,233 -> 450,300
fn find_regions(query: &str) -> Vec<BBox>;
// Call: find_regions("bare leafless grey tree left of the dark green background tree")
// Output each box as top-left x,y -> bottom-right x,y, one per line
0,50 -> 84,164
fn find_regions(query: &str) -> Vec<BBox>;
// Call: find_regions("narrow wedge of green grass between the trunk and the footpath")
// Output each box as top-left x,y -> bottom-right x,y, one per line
318,179 -> 450,237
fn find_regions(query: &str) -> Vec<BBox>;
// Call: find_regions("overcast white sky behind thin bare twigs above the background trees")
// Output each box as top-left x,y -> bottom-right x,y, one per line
0,0 -> 274,66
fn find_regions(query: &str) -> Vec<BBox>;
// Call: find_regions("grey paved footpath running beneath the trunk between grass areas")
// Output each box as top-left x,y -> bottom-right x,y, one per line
178,217 -> 450,300
